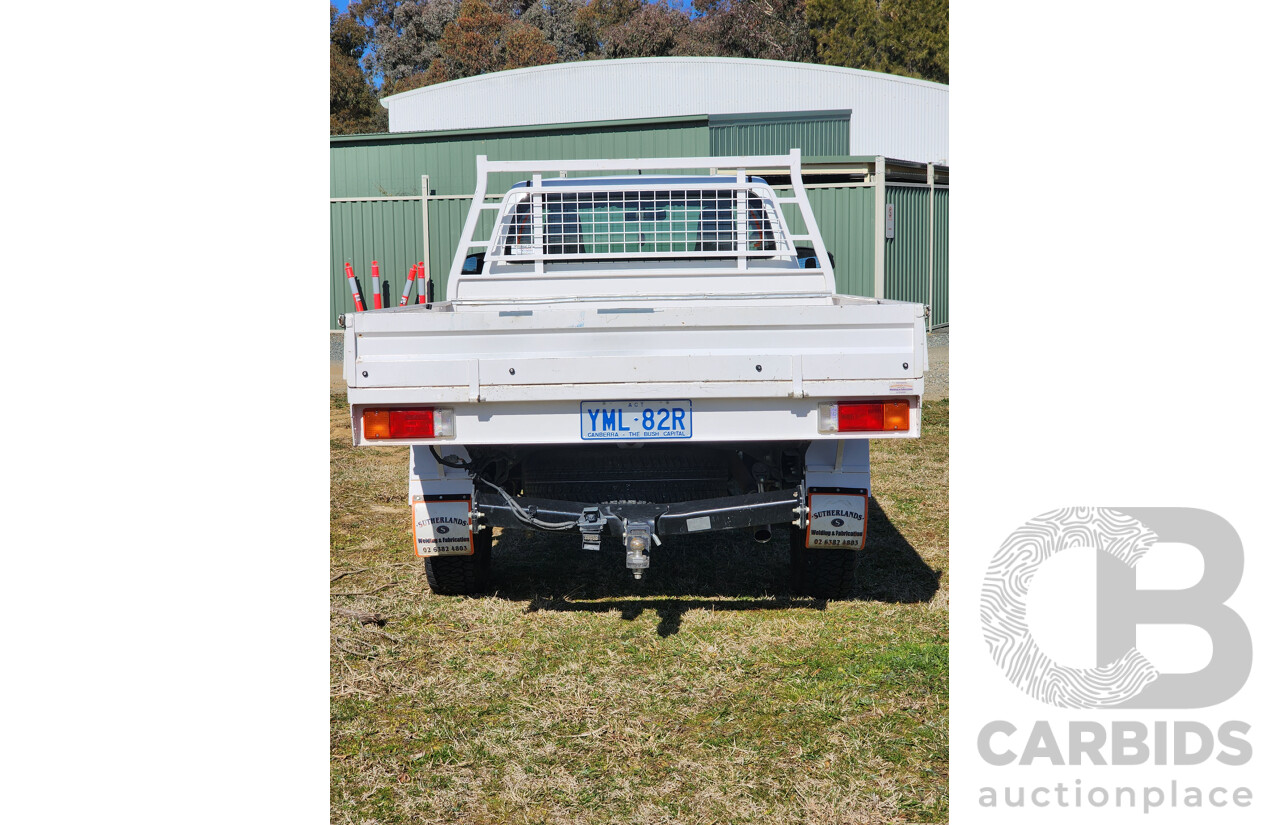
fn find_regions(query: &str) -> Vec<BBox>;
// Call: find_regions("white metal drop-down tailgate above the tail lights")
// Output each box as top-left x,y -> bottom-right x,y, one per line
344,302 -> 927,402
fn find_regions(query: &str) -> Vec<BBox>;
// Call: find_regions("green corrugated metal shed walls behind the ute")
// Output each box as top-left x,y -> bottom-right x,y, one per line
329,113 -> 948,329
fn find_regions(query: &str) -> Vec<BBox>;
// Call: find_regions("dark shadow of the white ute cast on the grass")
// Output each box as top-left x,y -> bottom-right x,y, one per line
490,498 -> 940,637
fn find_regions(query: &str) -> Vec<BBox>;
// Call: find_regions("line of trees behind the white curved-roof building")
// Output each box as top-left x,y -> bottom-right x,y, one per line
343,0 -> 948,106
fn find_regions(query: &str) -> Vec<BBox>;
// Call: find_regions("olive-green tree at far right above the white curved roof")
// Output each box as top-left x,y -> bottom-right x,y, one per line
809,0 -> 948,83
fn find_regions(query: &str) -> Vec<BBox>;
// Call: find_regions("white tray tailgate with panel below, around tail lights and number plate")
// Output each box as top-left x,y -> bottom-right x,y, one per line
344,298 -> 927,444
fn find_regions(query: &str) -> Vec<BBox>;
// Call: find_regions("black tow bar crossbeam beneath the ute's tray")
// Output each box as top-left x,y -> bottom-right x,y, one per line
475,487 -> 803,537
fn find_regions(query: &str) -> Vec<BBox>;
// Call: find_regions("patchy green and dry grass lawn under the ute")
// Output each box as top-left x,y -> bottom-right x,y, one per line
330,393 -> 947,825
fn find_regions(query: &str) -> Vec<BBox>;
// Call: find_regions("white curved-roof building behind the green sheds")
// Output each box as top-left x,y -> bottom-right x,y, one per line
381,58 -> 948,161
